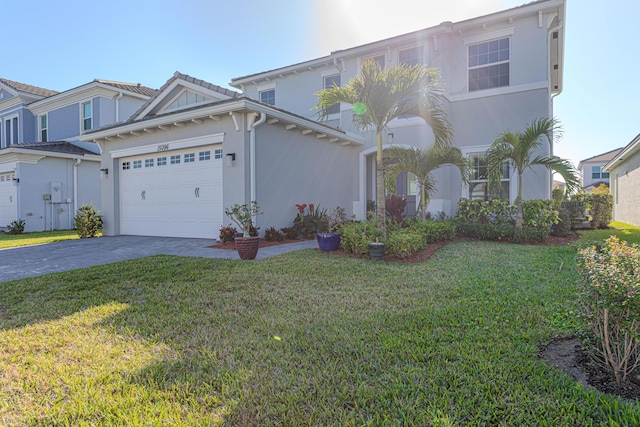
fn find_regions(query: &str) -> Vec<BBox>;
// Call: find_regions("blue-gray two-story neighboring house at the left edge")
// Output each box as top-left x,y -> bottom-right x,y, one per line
0,79 -> 154,231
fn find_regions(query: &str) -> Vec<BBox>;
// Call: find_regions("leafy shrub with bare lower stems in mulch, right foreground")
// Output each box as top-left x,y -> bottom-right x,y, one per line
578,236 -> 640,385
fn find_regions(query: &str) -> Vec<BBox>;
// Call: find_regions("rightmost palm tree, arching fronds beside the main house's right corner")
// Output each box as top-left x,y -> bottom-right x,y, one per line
487,118 -> 580,229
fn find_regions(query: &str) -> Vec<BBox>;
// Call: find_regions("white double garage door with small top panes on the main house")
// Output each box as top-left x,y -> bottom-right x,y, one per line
120,145 -> 223,238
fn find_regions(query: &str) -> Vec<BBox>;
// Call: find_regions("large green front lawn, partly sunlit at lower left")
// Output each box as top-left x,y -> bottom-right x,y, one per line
0,227 -> 640,426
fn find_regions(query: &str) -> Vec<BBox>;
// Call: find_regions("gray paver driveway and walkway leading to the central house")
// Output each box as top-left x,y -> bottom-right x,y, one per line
0,236 -> 318,282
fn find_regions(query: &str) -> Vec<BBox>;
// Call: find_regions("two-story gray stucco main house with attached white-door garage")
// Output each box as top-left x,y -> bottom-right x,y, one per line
83,0 -> 565,237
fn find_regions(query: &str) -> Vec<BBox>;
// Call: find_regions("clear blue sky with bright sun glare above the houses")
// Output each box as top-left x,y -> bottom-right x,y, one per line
0,0 -> 640,165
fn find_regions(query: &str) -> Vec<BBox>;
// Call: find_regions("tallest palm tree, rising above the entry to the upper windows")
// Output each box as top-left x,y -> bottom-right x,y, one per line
316,60 -> 453,235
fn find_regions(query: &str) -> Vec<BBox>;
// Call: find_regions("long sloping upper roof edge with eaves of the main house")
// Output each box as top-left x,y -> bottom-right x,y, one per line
230,0 -> 556,88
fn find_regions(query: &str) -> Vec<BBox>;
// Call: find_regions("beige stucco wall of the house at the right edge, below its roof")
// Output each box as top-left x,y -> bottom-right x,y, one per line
611,151 -> 640,226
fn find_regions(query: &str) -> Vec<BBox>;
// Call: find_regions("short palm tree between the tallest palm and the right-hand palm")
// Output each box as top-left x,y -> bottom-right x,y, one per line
384,145 -> 470,220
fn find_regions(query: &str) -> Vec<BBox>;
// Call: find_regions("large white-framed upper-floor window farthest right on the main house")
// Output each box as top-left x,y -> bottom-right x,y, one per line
469,37 -> 510,92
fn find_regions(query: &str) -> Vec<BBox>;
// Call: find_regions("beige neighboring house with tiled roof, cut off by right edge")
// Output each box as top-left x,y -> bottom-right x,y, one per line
603,134 -> 640,226
